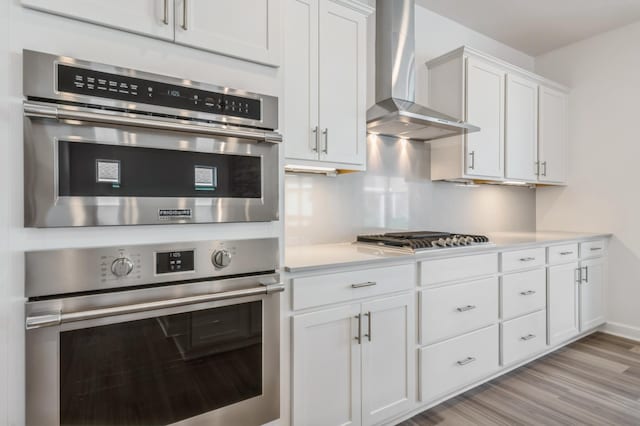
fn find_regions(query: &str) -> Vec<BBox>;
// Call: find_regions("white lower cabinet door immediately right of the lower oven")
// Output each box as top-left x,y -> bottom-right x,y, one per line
292,305 -> 362,426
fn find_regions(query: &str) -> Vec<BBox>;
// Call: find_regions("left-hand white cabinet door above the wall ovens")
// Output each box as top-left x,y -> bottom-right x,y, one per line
22,0 -> 174,40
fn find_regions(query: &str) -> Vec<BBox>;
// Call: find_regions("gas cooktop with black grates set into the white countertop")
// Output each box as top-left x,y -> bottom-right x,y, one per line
357,231 -> 491,252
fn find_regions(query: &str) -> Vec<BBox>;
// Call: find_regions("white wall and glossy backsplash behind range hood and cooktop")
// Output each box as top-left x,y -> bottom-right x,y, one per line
285,6 -> 535,245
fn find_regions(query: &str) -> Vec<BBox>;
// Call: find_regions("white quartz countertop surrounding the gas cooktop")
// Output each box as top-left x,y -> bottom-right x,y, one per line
285,231 -> 611,273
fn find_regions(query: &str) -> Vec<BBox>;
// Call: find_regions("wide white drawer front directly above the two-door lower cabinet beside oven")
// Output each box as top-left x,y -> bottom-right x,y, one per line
293,264 -> 415,310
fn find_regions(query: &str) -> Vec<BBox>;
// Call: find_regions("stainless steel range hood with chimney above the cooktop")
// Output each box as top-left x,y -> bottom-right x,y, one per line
367,0 -> 480,141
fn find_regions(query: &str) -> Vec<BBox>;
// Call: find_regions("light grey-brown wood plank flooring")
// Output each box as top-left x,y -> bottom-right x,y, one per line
401,333 -> 640,426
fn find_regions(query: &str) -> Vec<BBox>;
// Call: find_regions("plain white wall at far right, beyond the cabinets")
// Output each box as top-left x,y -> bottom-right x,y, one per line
536,22 -> 640,338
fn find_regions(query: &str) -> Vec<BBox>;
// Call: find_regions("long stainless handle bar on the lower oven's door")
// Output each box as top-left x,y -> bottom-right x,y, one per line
26,283 -> 284,330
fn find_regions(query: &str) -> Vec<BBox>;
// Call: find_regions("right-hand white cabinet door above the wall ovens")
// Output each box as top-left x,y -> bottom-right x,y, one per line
175,0 -> 281,67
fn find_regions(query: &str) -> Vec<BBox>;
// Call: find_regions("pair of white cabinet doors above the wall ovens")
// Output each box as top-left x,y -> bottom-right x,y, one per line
21,0 -> 282,66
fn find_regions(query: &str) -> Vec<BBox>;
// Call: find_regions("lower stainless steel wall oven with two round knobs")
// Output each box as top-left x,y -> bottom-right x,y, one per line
26,240 -> 283,426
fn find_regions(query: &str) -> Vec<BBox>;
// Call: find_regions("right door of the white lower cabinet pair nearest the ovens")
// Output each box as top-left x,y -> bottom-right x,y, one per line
362,294 -> 416,425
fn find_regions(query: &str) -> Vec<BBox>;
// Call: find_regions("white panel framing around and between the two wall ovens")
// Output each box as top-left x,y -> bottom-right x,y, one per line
0,0 -> 283,426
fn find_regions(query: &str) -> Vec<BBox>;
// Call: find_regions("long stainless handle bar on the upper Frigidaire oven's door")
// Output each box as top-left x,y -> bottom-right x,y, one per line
23,101 -> 282,143
